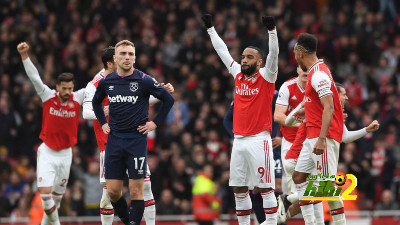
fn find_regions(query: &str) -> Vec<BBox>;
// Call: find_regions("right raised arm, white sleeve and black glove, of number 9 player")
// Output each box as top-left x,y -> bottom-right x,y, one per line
260,16 -> 279,83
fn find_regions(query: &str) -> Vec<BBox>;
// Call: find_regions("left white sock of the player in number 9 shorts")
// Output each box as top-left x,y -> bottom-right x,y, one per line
235,191 -> 252,225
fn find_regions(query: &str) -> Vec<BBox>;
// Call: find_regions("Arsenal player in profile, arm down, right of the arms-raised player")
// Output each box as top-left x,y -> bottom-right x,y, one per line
293,33 -> 346,224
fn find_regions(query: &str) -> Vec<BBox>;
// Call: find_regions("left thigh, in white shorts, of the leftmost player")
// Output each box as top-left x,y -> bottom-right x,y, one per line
36,143 -> 56,187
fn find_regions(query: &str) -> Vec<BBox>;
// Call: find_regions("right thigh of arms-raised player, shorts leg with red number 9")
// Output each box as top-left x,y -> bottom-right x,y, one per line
247,137 -> 275,189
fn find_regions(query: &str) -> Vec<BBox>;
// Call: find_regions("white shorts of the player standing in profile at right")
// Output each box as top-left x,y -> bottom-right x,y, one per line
295,138 -> 340,181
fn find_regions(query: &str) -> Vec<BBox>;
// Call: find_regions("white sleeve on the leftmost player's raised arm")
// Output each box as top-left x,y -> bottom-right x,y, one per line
22,57 -> 55,102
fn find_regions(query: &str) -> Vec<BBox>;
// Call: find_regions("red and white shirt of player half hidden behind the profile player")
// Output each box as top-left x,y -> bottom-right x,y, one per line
275,77 -> 305,143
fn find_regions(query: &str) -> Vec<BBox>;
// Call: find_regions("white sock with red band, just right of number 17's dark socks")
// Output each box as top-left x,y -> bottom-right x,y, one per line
143,176 -> 156,225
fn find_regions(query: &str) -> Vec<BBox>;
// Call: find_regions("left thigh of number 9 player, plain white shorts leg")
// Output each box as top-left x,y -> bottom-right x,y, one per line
229,138 -> 249,187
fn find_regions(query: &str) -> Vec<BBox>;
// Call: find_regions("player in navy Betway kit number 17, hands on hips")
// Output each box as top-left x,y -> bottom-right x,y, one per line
92,40 -> 174,225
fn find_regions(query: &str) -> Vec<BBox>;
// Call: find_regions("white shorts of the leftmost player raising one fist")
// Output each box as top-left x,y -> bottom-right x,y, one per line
37,143 -> 72,194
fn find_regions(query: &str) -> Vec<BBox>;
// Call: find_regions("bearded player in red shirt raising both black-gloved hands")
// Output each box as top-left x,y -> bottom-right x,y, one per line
202,14 -> 279,225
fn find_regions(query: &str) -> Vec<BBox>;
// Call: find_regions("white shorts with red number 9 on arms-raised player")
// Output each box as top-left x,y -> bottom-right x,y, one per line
229,131 -> 275,190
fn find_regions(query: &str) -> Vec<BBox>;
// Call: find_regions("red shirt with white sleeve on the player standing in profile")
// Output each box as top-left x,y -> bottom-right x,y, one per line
304,60 -> 344,143
